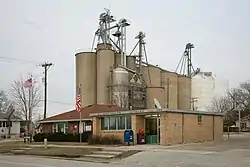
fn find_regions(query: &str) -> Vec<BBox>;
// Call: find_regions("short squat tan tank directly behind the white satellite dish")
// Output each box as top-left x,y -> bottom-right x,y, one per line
146,87 -> 165,108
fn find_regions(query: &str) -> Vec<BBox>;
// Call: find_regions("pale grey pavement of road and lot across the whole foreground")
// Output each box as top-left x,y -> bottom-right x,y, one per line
0,134 -> 250,167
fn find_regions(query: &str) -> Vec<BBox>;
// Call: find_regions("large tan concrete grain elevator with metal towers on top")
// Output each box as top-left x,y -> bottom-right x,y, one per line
75,10 -> 191,110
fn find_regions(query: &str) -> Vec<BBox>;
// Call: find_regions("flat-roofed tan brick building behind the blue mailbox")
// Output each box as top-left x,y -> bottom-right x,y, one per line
90,109 -> 223,145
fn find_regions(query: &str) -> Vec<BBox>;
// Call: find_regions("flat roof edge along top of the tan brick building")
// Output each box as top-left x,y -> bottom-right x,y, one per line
89,108 -> 224,117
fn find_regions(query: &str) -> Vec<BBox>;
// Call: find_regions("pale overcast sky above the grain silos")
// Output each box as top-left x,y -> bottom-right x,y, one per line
0,0 -> 250,115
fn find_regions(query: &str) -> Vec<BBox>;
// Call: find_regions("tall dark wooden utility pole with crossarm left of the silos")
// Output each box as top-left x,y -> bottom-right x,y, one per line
41,62 -> 53,119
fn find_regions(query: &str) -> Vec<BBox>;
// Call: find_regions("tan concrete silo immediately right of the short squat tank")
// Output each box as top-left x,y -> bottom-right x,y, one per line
161,70 -> 178,109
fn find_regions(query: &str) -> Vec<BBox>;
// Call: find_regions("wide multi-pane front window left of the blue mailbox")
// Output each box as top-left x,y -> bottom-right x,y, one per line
101,116 -> 131,130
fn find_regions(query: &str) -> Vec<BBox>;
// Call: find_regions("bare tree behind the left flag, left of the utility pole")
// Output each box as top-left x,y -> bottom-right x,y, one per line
11,76 -> 41,142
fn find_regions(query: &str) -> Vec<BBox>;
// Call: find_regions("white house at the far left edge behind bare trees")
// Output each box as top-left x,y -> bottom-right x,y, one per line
0,113 -> 21,138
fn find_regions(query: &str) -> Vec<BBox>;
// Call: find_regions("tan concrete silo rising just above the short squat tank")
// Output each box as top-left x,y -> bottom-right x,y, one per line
142,65 -> 161,87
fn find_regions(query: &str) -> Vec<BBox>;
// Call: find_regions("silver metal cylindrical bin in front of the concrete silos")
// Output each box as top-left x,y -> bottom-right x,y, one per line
112,67 -> 129,108
